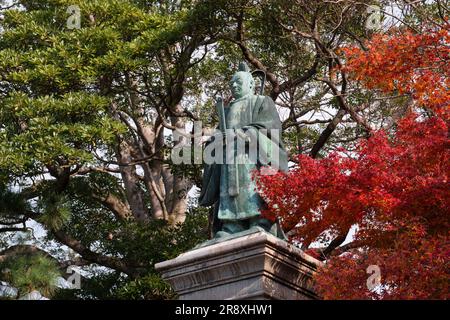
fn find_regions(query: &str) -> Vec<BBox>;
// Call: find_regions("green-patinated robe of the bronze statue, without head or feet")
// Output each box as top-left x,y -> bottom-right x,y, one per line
199,95 -> 287,233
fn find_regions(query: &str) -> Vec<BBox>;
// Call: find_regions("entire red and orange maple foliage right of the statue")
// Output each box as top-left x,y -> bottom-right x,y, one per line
257,29 -> 450,299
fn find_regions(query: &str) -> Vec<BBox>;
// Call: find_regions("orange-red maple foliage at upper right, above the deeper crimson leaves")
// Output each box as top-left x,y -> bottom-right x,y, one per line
342,23 -> 450,119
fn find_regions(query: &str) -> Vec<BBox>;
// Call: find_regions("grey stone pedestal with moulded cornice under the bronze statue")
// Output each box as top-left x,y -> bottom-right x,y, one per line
155,231 -> 321,300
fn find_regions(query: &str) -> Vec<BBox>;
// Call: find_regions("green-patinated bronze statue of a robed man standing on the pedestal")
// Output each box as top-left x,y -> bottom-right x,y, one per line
199,63 -> 287,238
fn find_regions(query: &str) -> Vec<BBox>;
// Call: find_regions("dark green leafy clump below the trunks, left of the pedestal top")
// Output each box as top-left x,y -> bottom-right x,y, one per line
52,202 -> 208,270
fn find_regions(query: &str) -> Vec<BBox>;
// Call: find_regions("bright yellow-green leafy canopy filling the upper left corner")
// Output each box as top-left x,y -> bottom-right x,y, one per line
0,0 -> 200,175
